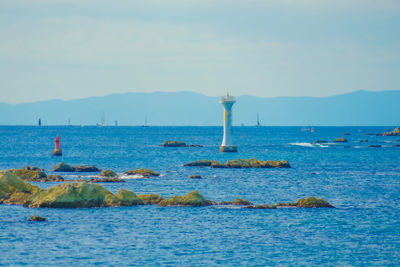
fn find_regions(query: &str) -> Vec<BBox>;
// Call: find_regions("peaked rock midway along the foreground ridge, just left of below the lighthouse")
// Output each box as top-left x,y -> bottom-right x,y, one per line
157,190 -> 216,207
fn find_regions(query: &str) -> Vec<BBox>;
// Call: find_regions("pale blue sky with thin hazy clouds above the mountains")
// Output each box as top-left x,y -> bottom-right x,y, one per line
0,0 -> 400,103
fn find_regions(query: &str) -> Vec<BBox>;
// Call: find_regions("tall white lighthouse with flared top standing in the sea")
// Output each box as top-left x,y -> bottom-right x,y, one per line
219,93 -> 237,152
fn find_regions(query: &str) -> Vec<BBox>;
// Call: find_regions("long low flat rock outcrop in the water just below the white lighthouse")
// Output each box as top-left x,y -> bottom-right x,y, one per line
184,158 -> 290,168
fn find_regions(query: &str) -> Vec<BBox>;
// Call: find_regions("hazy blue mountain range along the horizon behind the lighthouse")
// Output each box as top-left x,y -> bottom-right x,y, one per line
0,90 -> 400,126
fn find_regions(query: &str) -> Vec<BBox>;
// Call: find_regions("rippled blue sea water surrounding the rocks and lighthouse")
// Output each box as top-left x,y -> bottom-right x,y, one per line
0,126 -> 400,266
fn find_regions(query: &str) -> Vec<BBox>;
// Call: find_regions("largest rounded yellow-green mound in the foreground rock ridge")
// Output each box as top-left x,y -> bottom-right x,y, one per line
28,183 -> 122,208
